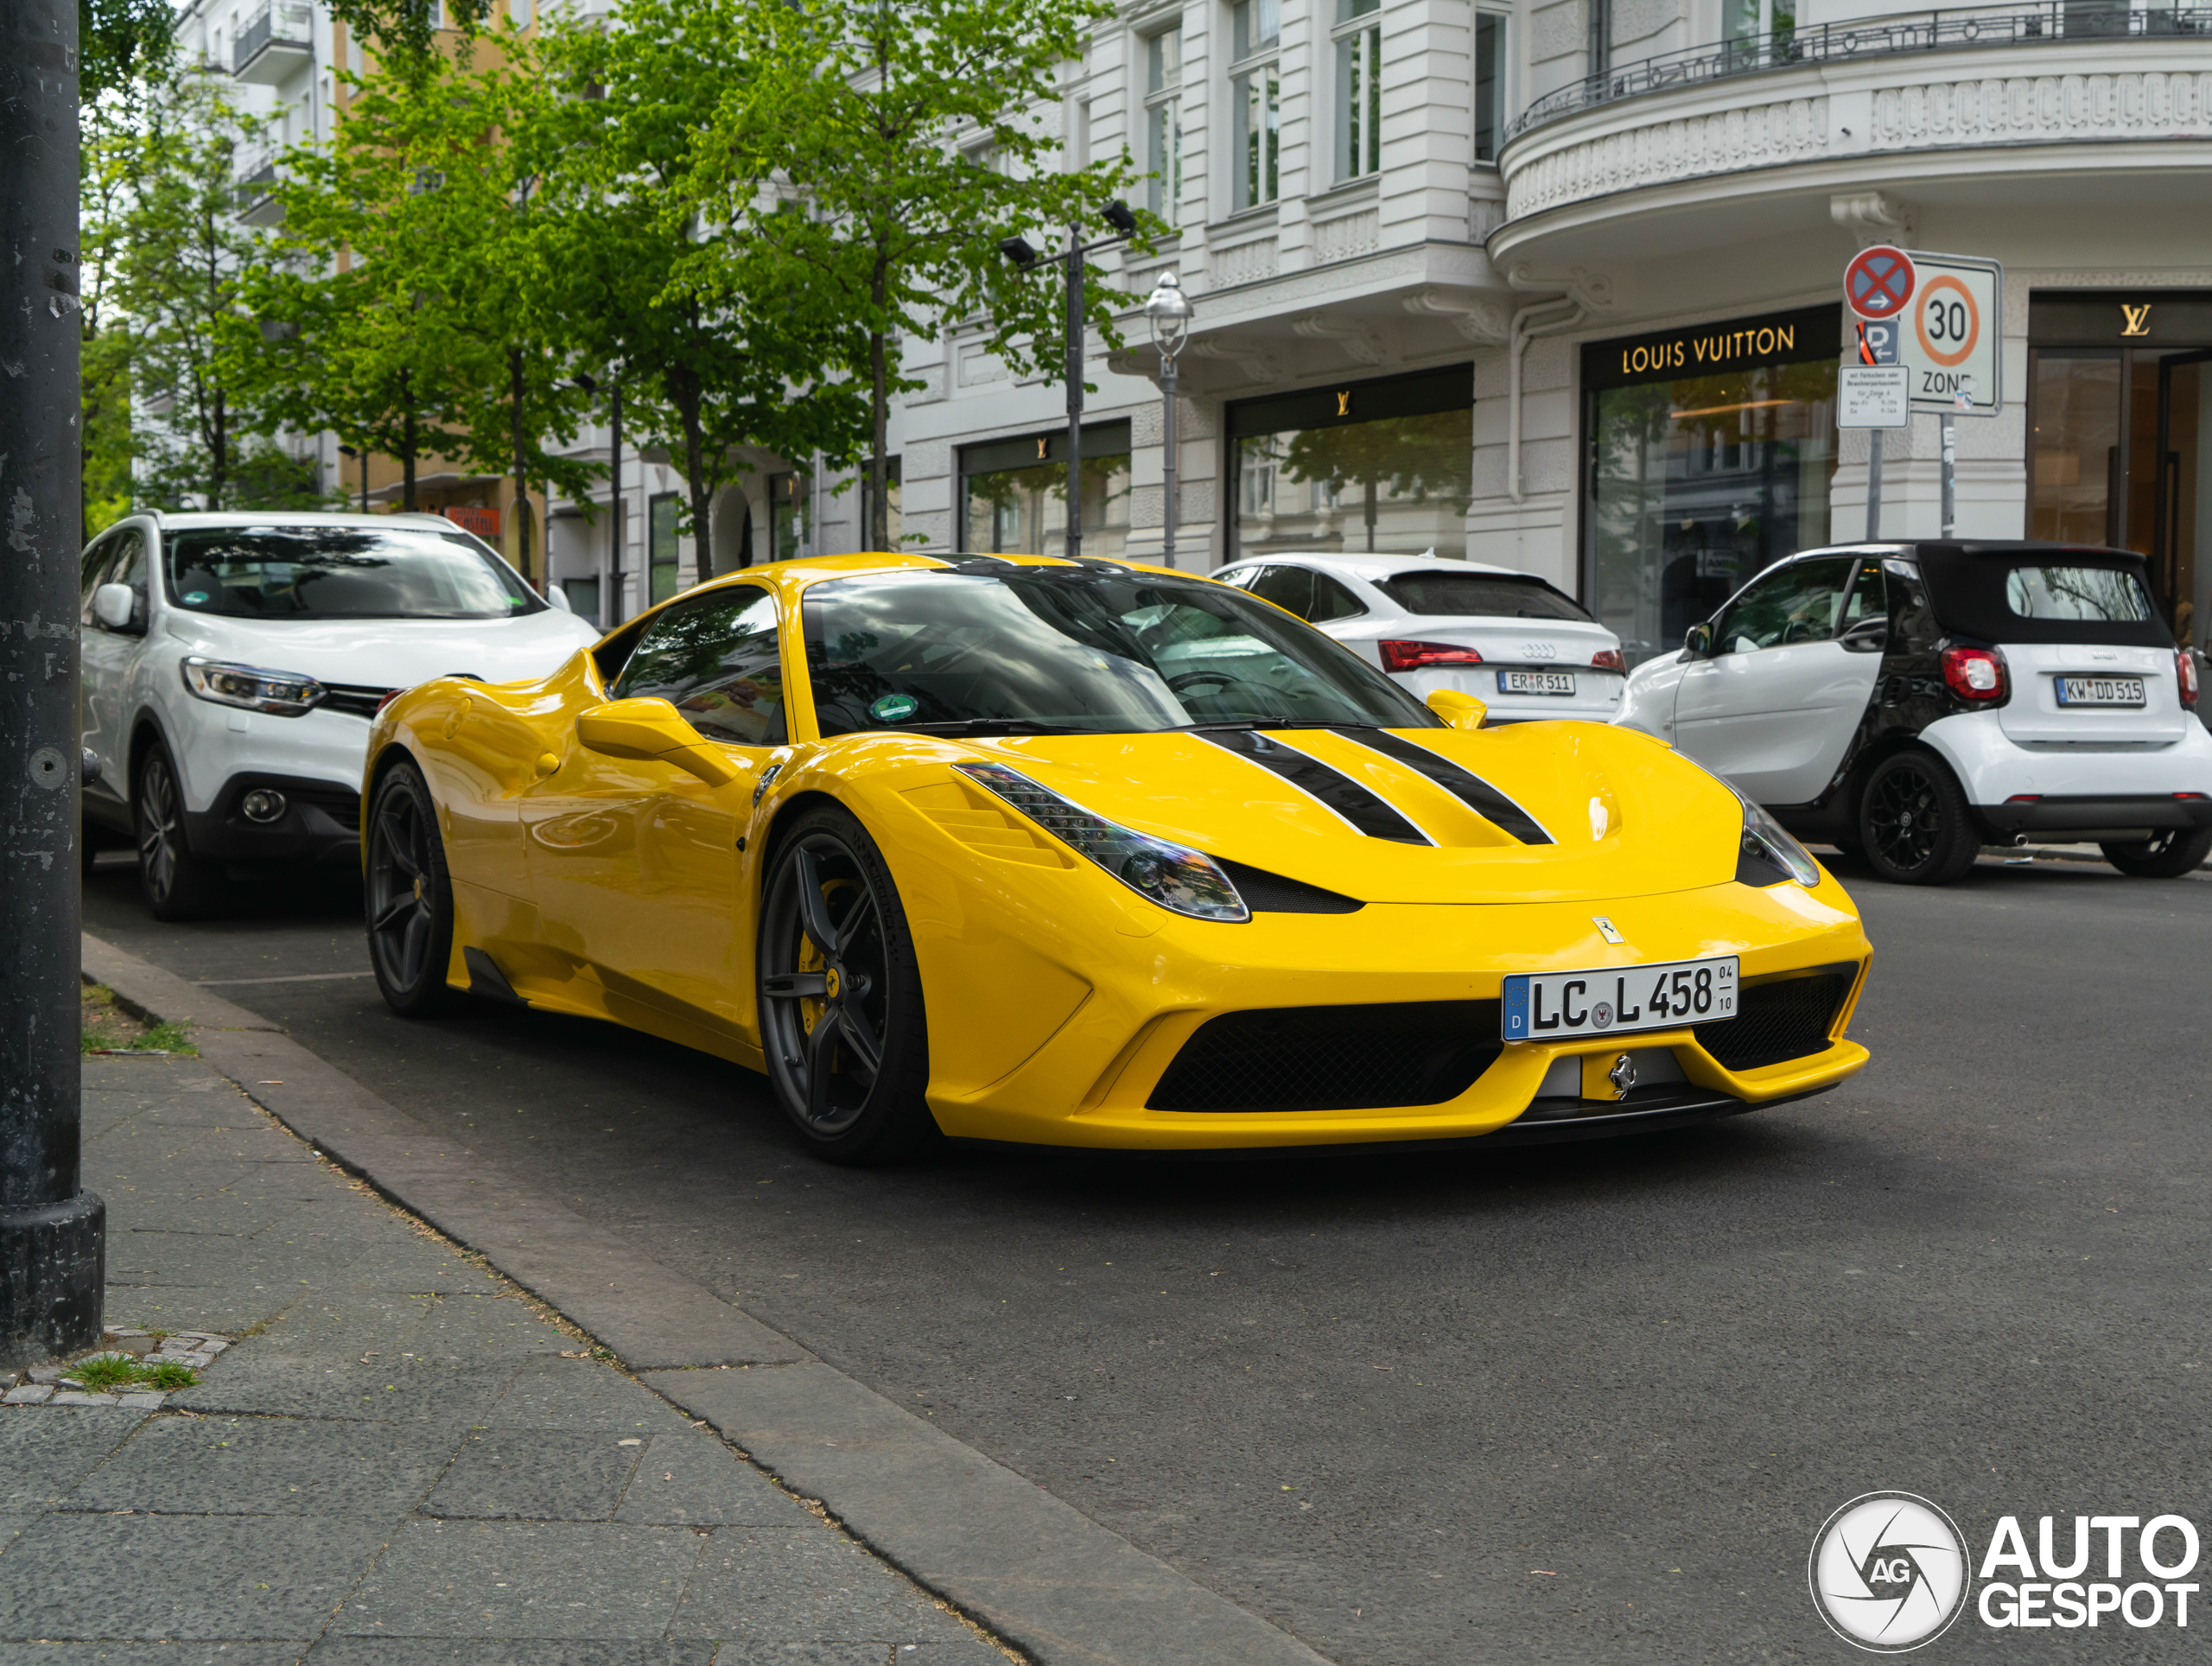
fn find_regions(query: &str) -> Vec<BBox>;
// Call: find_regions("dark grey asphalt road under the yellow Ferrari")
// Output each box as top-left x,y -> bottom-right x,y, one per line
84,858 -> 2212,1666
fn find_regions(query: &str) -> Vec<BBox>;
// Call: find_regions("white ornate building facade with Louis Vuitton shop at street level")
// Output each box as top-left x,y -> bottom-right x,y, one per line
889,0 -> 2212,657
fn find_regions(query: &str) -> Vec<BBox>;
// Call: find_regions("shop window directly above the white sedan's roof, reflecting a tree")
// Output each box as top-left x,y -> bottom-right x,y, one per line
1230,365 -> 1476,560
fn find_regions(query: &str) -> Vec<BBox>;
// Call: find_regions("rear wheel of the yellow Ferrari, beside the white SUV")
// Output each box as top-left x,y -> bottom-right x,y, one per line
360,763 -> 458,1018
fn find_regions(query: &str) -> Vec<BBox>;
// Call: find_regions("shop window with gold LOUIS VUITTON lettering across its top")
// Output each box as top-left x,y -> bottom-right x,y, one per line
1584,308 -> 1838,664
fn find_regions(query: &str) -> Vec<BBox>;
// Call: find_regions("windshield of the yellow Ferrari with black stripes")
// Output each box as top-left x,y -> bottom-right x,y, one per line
801,560 -> 1438,737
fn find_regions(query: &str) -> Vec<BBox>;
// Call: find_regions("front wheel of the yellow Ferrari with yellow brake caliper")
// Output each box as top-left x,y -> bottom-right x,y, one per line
757,805 -> 938,1164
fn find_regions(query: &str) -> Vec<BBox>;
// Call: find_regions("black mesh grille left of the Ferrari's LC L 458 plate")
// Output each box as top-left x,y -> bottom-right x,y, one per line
1148,1000 -> 1504,1110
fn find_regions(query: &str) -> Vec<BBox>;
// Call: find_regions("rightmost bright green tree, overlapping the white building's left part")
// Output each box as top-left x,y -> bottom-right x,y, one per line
694,0 -> 1161,549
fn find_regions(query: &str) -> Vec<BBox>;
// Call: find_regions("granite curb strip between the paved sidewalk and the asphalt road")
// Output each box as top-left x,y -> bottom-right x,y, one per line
84,933 -> 1327,1666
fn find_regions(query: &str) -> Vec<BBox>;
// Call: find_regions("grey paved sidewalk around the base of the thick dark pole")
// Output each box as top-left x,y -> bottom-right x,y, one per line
0,1058 -> 1008,1666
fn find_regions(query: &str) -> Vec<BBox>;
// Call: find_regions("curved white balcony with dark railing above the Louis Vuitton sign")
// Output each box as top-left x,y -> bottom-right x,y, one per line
1489,0 -> 2212,270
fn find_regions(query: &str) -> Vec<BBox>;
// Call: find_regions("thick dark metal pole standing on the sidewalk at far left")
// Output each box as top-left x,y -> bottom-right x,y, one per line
0,0 -> 106,1367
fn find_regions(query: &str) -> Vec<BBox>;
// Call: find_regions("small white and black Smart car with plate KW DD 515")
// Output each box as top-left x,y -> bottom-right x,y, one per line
1619,540 -> 2212,885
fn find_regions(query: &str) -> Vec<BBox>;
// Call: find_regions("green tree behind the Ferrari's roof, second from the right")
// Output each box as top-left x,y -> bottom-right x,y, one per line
536,0 -> 865,553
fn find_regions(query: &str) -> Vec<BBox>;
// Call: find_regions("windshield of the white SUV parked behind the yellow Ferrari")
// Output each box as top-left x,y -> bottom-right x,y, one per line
162,522 -> 544,620
